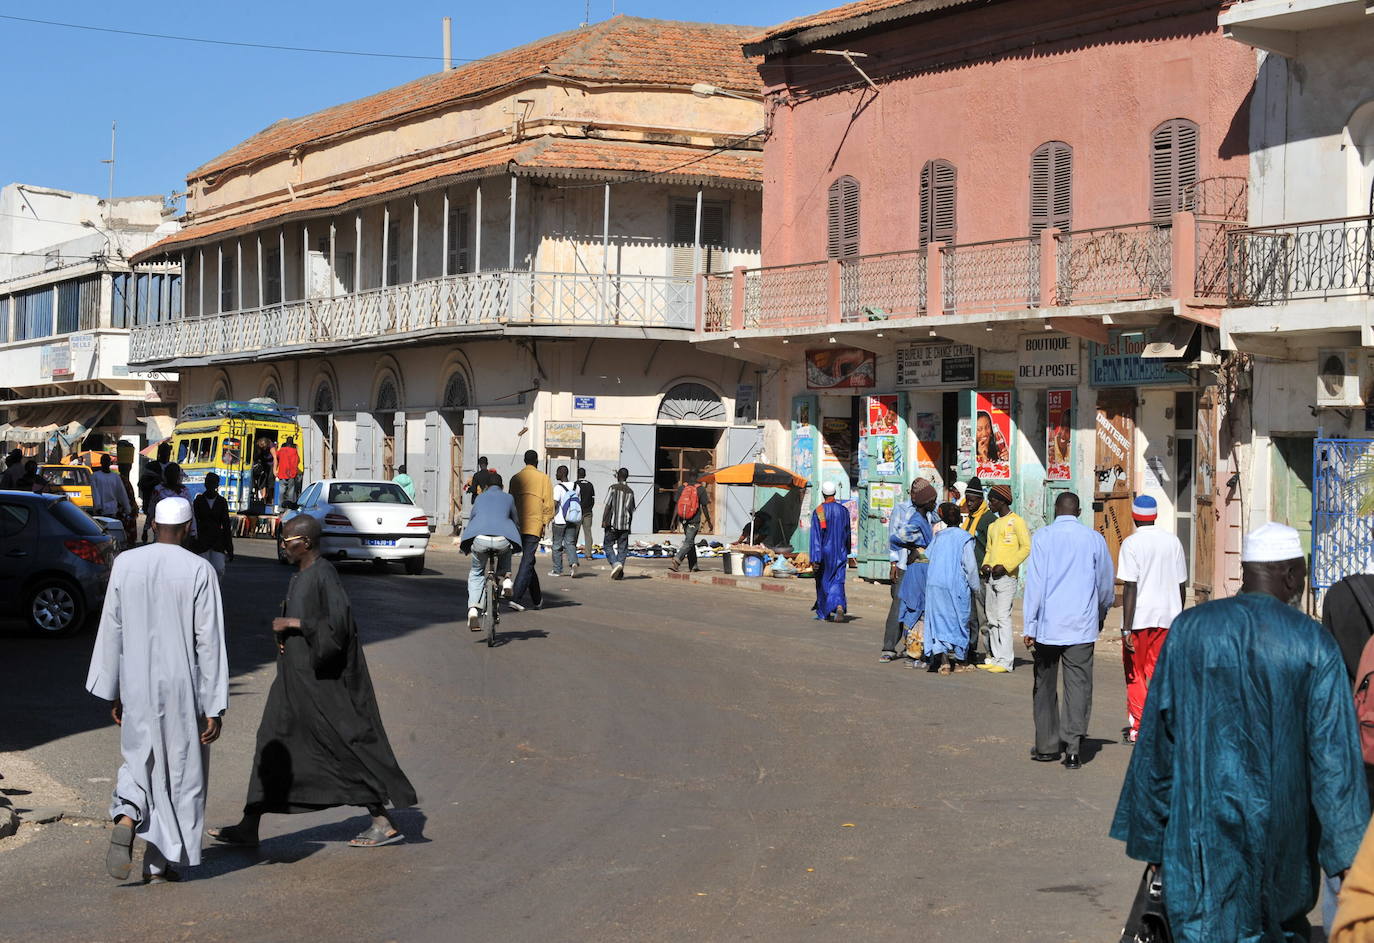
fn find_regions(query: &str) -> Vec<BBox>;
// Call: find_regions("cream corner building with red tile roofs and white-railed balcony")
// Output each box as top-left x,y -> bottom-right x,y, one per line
133,16 -> 763,532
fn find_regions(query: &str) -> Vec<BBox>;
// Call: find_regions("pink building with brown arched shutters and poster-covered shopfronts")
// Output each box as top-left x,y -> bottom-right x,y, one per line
698,0 -> 1254,592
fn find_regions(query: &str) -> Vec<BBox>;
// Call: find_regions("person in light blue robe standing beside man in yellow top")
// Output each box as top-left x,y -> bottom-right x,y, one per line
926,503 -> 978,675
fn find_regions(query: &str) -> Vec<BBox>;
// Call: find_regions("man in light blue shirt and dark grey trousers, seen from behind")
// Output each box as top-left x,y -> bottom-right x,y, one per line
1022,491 -> 1116,770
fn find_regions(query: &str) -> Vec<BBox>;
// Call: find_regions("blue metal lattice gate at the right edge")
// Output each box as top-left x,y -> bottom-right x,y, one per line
1312,439 -> 1374,591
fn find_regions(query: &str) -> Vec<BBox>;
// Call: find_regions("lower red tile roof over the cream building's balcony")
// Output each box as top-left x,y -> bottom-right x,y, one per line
132,137 -> 764,261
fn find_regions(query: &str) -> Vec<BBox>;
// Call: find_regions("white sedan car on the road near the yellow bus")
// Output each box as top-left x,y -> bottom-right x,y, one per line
276,478 -> 429,575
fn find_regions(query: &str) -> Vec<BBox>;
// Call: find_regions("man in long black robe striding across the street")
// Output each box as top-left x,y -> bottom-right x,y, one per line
210,515 -> 415,848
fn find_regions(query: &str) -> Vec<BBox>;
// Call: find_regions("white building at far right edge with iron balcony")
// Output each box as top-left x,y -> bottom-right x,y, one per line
1220,0 -> 1374,590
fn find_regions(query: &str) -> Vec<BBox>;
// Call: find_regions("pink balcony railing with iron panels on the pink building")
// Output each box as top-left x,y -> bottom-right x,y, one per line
701,213 -> 1220,334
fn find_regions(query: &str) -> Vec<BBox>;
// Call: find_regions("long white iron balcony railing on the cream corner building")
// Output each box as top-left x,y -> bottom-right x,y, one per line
129,271 -> 695,364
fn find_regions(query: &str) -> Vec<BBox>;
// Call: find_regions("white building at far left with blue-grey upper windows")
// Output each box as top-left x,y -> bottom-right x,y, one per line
0,183 -> 181,461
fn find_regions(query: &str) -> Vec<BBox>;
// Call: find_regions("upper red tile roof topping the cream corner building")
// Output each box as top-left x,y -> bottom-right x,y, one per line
188,15 -> 761,180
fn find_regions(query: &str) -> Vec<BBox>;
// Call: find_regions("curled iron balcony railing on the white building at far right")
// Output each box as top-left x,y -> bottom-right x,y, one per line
1226,216 -> 1374,305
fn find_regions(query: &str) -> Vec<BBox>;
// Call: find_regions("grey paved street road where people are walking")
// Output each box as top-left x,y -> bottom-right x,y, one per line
0,542 -> 1139,943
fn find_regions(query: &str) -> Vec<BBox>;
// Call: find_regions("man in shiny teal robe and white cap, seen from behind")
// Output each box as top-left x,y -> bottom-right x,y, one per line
1112,524 -> 1370,943
